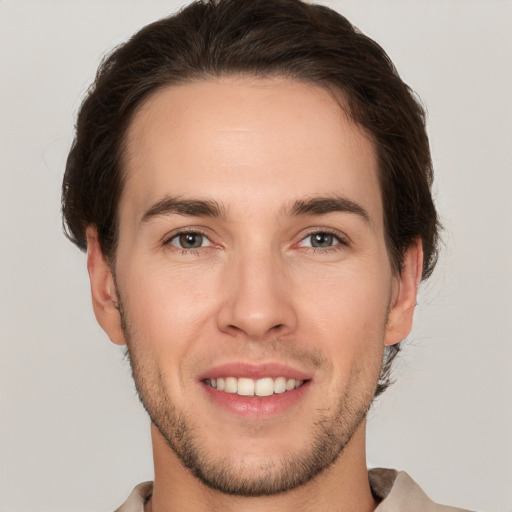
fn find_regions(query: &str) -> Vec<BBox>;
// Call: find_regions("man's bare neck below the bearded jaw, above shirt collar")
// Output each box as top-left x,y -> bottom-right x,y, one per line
145,421 -> 377,512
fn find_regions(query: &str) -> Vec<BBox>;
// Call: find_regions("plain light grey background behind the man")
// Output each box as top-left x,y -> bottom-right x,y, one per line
0,0 -> 512,512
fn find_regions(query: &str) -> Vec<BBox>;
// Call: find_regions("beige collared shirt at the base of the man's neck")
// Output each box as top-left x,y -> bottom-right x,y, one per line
115,468 -> 469,512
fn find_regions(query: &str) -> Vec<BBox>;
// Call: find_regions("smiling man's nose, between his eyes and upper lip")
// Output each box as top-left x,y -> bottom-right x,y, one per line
218,251 -> 297,341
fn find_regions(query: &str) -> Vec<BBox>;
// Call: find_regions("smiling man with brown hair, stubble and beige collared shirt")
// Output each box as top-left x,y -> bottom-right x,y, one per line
63,0 -> 472,512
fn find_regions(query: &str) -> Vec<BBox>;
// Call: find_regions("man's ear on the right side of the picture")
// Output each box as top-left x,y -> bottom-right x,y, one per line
384,239 -> 423,345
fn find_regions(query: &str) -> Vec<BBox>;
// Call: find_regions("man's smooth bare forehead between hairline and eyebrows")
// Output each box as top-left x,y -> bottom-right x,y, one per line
120,78 -> 382,223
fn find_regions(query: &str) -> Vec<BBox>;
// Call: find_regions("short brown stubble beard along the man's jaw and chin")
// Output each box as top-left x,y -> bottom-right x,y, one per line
118,295 -> 378,497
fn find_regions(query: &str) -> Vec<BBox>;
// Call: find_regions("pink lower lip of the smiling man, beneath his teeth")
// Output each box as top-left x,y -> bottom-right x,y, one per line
201,381 -> 311,418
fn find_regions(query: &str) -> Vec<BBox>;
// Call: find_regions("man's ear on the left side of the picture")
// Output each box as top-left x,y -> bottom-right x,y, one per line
86,226 -> 125,345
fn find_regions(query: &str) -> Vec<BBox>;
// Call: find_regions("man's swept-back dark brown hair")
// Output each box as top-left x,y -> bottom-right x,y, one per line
62,0 -> 439,396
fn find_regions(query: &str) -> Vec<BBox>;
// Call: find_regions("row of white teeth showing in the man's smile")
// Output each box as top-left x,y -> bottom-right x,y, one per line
204,377 -> 304,396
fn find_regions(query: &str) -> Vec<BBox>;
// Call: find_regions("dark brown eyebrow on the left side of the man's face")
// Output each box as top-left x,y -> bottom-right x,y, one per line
141,196 -> 226,224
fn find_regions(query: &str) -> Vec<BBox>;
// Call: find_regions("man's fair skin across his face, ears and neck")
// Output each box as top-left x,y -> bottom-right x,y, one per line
87,77 -> 422,512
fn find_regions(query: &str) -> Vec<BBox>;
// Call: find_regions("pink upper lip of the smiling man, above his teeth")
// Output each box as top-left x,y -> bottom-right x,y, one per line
198,361 -> 312,380
